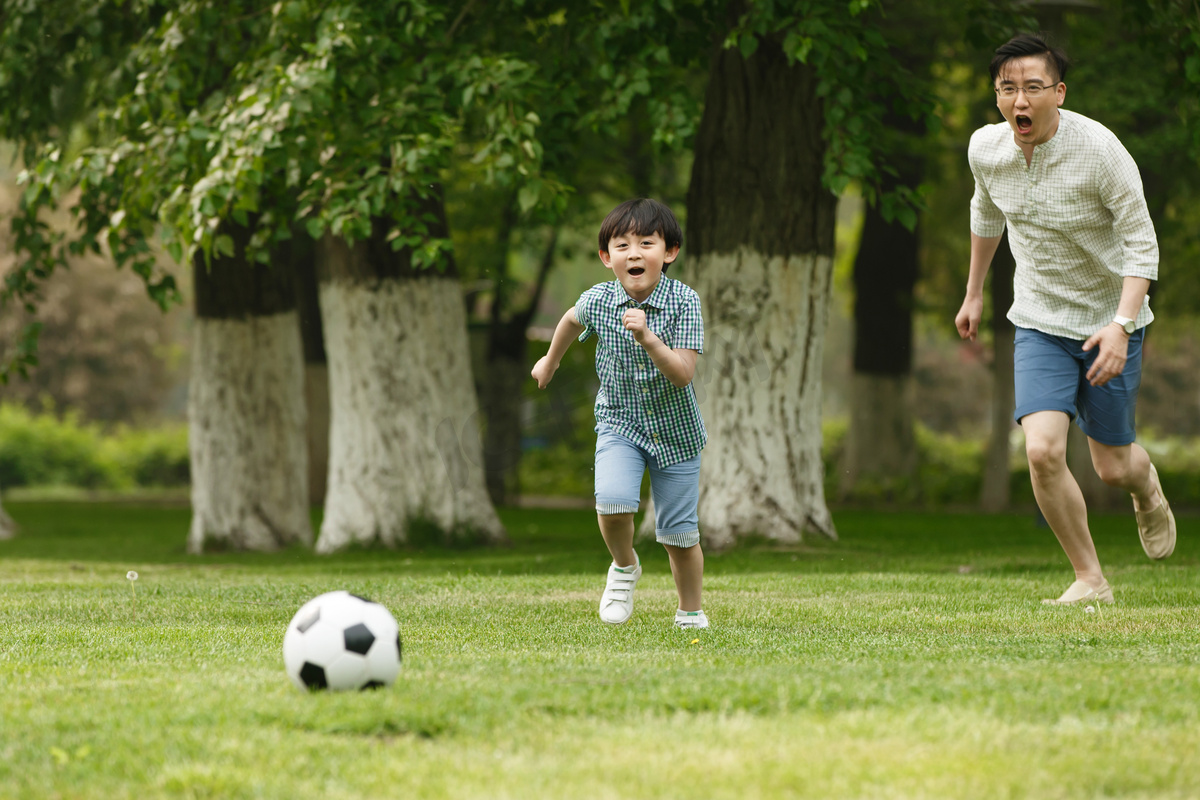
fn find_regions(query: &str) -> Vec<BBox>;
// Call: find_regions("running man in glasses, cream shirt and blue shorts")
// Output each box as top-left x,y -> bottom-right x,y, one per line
954,35 -> 1175,604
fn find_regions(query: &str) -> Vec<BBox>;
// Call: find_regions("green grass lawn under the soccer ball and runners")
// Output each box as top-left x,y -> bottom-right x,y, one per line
0,503 -> 1200,800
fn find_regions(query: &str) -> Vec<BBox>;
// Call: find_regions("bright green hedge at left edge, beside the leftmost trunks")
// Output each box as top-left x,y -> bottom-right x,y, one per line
0,403 -> 188,491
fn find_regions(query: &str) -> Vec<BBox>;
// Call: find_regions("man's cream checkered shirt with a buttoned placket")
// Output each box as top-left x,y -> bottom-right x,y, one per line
967,109 -> 1158,339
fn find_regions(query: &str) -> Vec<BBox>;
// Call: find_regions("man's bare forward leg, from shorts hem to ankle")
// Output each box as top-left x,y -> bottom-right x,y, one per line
1021,411 -> 1105,589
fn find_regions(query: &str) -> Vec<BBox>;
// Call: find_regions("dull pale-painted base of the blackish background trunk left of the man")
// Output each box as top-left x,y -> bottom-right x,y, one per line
838,373 -> 917,498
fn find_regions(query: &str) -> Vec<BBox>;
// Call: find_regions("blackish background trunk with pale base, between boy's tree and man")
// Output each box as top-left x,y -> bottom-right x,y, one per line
838,175 -> 923,498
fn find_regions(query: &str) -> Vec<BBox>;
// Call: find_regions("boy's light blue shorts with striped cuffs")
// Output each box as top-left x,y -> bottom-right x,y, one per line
596,423 -> 700,547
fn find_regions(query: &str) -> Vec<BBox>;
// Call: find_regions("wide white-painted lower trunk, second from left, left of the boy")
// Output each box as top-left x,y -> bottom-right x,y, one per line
317,277 -> 506,553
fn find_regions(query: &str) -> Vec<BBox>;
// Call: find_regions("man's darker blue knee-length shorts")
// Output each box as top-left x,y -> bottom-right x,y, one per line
1013,327 -> 1145,447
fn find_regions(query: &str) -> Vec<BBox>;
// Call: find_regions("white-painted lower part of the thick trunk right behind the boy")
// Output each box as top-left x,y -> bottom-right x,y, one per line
688,247 -> 836,549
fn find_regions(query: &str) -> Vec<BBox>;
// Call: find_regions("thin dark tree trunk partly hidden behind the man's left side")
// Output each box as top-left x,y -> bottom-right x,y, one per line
979,231 -> 1016,511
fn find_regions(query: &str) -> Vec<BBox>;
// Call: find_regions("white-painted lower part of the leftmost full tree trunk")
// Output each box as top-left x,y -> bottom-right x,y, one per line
187,311 -> 312,553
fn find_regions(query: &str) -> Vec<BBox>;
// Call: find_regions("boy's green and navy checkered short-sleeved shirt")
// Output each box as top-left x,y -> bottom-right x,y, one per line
575,275 -> 708,467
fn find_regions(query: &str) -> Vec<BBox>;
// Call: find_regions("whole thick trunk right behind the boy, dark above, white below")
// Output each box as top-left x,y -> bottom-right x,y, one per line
684,40 -> 836,548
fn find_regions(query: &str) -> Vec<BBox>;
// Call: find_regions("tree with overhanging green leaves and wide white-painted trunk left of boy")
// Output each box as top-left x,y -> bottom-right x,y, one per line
5,0 -> 553,551
